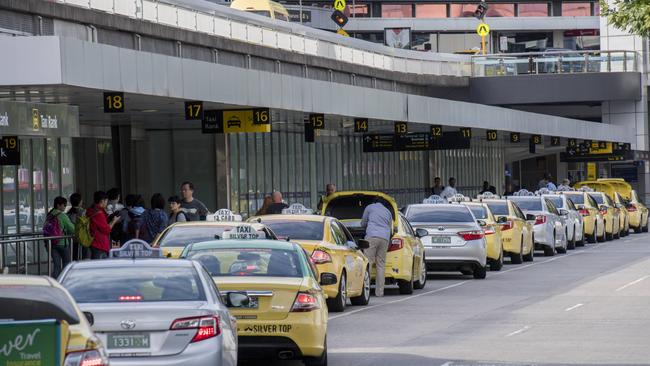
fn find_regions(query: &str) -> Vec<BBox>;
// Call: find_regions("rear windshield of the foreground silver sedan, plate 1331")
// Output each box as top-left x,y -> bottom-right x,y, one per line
62,265 -> 205,303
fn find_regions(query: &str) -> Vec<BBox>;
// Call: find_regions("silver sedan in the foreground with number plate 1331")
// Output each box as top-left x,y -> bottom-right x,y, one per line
59,258 -> 240,366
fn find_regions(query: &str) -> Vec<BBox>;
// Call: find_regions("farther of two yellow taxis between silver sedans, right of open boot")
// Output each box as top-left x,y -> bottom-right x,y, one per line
477,194 -> 535,264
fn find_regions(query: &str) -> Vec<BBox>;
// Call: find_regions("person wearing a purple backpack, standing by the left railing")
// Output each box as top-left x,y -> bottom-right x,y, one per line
43,197 -> 74,278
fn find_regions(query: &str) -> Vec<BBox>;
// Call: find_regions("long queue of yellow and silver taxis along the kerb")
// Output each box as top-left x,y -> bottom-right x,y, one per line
7,179 -> 648,366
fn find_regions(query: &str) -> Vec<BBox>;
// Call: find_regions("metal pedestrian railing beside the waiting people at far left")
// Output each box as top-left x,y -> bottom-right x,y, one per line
0,233 -> 74,276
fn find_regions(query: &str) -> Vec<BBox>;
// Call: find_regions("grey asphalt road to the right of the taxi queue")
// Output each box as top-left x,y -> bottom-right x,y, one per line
252,234 -> 650,366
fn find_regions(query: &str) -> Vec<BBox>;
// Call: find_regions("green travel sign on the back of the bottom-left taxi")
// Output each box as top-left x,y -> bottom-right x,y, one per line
0,320 -> 61,366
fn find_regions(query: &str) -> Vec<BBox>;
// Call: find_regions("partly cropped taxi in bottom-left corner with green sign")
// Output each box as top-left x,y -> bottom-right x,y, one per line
0,275 -> 108,366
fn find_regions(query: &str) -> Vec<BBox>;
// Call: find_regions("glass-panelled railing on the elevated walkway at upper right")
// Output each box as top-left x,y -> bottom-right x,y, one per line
472,50 -> 639,77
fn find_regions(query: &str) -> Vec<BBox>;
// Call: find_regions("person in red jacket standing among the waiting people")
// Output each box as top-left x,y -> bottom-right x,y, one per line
86,191 -> 120,259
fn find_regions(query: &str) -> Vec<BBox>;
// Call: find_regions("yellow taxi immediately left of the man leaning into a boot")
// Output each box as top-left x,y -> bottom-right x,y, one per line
249,204 -> 370,312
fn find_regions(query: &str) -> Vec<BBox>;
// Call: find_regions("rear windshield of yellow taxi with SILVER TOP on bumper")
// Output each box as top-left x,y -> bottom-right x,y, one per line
188,248 -> 308,277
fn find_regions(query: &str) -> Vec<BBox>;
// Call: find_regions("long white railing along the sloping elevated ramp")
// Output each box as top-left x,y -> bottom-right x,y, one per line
45,0 -> 471,76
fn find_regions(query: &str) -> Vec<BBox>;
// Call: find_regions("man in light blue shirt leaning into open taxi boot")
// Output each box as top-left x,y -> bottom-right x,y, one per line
361,198 -> 393,297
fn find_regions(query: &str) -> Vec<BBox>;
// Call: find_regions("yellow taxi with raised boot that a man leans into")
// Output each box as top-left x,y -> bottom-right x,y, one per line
321,191 -> 427,294
